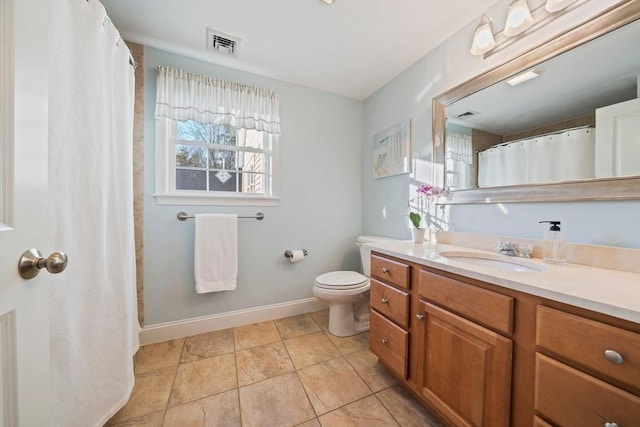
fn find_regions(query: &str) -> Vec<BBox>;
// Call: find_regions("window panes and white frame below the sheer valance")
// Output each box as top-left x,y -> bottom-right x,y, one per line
156,119 -> 277,205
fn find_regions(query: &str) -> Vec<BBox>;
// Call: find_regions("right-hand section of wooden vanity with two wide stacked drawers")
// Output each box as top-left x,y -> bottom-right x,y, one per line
535,306 -> 640,427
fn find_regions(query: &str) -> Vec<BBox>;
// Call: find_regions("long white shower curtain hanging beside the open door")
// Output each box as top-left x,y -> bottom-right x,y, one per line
49,0 -> 139,426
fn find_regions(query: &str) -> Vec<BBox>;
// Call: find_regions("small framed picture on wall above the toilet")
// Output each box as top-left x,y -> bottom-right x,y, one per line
373,120 -> 411,178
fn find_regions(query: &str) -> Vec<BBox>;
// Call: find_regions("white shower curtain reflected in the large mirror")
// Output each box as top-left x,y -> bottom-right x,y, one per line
478,128 -> 595,187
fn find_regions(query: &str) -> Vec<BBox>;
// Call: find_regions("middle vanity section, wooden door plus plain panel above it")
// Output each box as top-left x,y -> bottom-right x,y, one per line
418,270 -> 513,426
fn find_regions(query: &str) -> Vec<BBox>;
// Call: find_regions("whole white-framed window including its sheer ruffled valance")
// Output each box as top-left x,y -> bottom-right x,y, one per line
155,67 -> 280,205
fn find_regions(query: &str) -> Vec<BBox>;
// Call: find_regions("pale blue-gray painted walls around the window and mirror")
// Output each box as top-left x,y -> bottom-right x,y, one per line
144,0 -> 640,325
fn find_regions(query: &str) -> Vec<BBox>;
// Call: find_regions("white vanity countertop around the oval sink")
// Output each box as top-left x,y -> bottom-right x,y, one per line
366,240 -> 640,323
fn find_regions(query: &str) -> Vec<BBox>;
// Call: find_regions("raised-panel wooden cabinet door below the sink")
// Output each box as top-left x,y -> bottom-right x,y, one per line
421,302 -> 512,427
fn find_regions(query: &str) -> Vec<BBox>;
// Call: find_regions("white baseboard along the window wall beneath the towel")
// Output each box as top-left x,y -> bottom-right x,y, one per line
140,298 -> 328,345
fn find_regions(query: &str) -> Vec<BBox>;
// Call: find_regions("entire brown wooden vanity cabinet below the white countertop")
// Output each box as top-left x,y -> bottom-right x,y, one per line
369,251 -> 640,427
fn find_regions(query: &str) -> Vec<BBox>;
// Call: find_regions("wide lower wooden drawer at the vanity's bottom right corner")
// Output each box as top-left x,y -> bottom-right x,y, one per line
535,353 -> 640,427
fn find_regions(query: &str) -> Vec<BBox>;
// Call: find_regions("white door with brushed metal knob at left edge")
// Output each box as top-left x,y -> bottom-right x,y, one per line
0,0 -> 52,427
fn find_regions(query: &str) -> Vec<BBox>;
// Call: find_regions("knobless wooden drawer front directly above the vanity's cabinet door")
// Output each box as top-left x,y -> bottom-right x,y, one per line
419,270 -> 513,335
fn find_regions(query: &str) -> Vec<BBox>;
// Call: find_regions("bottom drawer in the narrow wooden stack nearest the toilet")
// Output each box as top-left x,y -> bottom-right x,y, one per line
369,310 -> 409,379
